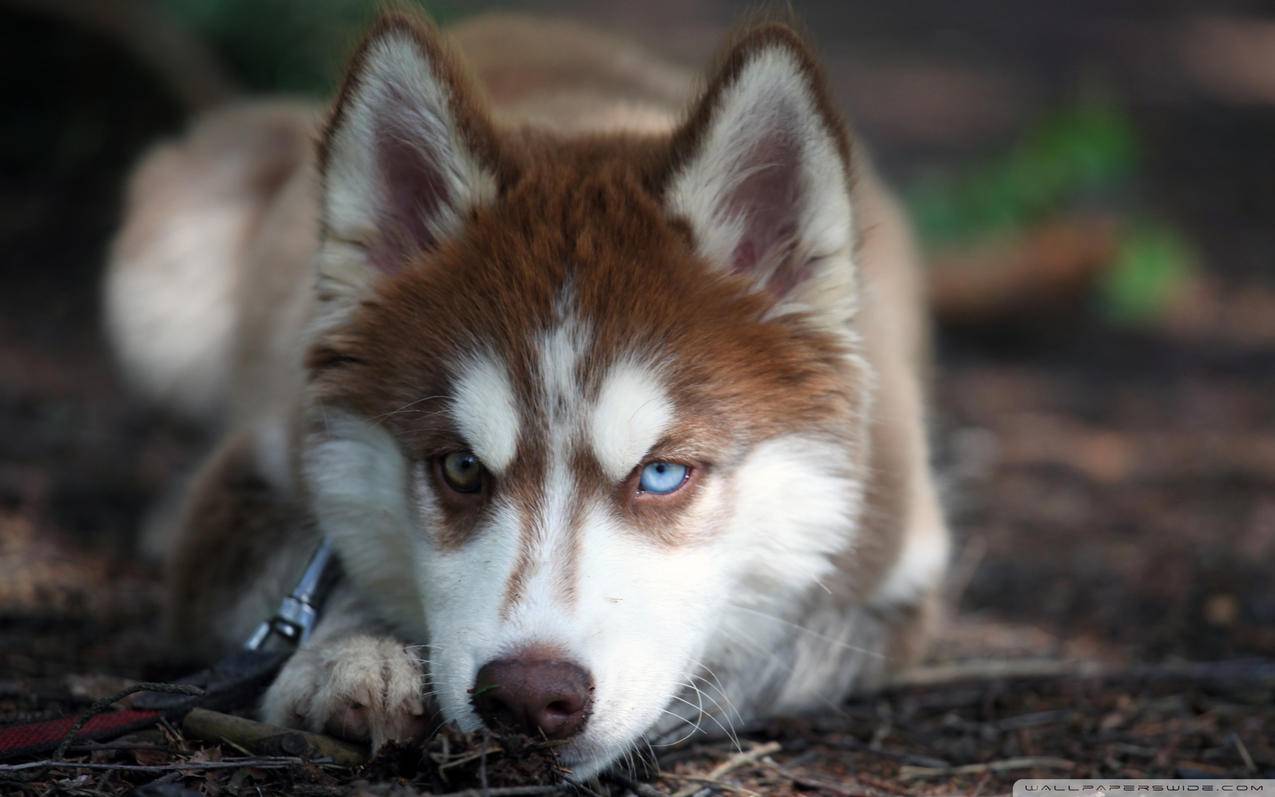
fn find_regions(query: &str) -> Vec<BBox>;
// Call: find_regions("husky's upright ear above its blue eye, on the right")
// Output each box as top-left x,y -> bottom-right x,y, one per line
664,26 -> 854,315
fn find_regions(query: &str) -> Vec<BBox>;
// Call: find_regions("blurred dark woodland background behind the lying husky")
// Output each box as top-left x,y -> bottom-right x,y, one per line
0,0 -> 1275,678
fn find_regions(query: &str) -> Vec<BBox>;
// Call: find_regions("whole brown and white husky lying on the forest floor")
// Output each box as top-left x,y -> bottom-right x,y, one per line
107,18 -> 947,774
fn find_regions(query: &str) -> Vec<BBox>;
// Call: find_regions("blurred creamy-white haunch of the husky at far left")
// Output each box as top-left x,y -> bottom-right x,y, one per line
103,102 -> 315,426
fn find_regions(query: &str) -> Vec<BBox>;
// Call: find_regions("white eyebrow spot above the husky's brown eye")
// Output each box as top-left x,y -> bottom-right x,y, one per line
450,355 -> 520,476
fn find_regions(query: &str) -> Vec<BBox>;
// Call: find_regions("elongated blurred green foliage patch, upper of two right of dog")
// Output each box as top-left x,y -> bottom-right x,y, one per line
909,102 -> 1137,245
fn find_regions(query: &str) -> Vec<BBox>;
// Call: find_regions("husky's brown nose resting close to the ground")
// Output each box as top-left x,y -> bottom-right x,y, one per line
473,658 -> 593,738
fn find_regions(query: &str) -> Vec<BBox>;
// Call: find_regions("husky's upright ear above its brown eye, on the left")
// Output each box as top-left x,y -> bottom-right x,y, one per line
319,15 -> 499,317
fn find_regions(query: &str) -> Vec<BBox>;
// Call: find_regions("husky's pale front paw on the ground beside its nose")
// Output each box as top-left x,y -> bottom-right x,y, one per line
261,636 -> 428,750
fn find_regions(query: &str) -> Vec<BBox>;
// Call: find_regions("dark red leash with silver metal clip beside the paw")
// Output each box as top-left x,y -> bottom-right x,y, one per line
0,539 -> 340,759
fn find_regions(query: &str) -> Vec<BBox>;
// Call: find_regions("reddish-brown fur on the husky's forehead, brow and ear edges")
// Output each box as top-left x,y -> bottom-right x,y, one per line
310,17 -> 862,571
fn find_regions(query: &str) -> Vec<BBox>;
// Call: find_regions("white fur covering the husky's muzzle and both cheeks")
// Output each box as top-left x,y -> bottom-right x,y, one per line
307,382 -> 859,777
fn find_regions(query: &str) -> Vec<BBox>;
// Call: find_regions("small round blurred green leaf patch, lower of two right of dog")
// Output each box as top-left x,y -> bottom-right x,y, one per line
1098,226 -> 1195,324
